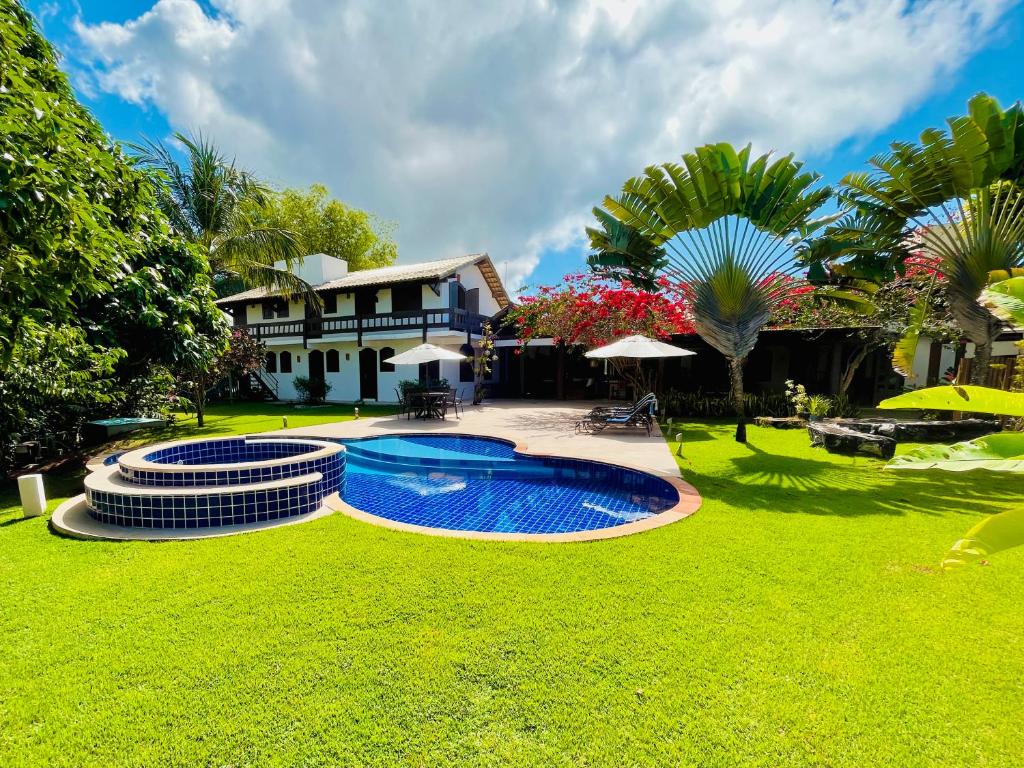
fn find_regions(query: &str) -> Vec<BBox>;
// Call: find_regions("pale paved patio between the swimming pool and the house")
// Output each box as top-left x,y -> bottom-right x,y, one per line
276,400 -> 681,478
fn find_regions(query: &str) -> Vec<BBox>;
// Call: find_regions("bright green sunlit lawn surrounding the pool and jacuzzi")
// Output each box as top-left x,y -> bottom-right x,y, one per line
0,406 -> 1024,768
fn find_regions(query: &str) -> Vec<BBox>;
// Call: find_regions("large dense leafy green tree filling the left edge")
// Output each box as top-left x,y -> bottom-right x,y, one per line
0,2 -> 225,450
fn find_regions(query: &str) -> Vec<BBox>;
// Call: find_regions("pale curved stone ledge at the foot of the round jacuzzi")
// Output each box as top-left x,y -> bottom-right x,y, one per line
49,493 -> 340,542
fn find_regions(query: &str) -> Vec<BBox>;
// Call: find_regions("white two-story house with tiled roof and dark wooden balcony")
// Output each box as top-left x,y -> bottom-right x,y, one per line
217,254 -> 509,402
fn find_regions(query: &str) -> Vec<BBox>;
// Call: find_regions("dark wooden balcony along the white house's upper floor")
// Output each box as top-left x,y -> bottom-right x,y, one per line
241,307 -> 487,346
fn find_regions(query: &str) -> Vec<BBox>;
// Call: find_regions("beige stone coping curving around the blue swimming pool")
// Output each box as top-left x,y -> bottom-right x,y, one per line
329,432 -> 703,544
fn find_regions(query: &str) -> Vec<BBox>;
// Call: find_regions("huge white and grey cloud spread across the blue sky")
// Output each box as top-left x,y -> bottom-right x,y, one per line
70,0 -> 1009,286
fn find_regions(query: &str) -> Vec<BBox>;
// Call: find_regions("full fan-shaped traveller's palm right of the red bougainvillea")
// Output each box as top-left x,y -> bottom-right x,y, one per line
592,143 -> 831,442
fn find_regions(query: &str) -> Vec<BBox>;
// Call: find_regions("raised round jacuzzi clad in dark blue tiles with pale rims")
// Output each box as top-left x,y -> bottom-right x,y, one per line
85,437 -> 345,528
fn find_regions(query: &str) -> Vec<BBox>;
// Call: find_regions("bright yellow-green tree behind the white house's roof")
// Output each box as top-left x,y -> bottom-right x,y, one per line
263,184 -> 398,270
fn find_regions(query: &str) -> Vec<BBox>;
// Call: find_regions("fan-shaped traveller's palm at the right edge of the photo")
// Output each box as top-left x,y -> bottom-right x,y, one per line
816,94 -> 1024,384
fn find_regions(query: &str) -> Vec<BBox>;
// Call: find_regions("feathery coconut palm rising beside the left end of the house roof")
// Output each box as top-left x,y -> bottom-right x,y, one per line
131,133 -> 310,294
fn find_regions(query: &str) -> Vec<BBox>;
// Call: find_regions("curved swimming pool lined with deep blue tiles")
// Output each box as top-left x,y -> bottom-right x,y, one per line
339,435 -> 680,536
